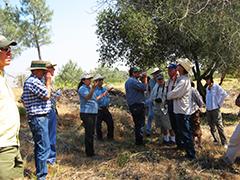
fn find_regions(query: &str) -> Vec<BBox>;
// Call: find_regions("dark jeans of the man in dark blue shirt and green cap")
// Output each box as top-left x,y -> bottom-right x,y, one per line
129,103 -> 145,145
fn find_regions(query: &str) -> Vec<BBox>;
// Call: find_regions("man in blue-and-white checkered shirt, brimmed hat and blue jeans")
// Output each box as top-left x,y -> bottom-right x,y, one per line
22,60 -> 51,179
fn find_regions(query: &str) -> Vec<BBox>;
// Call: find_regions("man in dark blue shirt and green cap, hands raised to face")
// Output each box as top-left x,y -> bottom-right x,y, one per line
125,67 -> 147,145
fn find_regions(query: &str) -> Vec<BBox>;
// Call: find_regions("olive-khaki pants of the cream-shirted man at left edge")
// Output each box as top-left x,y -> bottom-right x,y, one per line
0,146 -> 23,180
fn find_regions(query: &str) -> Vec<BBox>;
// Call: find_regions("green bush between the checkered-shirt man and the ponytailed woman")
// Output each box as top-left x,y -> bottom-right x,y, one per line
55,60 -> 83,89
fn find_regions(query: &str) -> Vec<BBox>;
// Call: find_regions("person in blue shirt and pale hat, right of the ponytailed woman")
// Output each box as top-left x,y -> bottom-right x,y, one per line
93,74 -> 114,140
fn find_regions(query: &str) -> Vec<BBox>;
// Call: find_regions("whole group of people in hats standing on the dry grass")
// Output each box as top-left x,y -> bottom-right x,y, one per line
0,35 -> 240,180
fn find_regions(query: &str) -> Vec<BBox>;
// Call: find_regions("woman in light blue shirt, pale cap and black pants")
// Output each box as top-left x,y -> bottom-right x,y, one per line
78,73 -> 98,157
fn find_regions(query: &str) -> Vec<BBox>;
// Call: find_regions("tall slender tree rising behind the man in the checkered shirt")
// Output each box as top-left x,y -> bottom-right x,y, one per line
20,0 -> 53,59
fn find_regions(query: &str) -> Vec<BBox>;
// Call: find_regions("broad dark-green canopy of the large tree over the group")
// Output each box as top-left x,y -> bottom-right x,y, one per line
97,0 -> 240,94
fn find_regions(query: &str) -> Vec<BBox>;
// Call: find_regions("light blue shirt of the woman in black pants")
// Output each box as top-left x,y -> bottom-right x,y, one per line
78,84 -> 98,114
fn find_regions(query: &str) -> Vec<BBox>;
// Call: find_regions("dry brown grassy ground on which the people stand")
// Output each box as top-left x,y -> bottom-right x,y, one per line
15,80 -> 240,180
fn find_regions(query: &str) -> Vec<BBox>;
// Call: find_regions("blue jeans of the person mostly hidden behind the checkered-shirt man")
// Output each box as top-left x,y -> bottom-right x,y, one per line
47,108 -> 57,164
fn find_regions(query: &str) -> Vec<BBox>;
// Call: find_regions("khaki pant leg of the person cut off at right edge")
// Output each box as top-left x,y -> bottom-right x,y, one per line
225,124 -> 240,163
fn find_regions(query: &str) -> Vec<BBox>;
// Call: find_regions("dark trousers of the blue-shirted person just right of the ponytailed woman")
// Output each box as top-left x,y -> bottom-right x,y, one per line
96,108 -> 114,139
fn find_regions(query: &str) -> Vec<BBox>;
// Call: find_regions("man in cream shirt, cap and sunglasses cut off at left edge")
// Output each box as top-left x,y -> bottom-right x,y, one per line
0,35 -> 23,179
